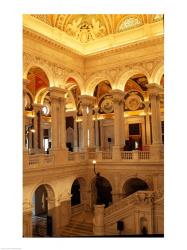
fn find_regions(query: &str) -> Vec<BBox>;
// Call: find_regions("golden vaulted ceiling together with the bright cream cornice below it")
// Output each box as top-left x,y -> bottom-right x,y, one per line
23,14 -> 163,56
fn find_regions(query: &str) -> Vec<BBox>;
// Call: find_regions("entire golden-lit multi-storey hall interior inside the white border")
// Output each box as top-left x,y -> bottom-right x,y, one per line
23,14 -> 164,237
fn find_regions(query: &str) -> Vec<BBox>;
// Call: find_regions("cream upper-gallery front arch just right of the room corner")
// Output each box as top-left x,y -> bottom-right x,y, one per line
85,73 -> 114,96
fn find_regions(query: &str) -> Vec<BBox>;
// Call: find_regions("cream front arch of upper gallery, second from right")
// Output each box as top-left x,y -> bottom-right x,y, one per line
116,66 -> 150,91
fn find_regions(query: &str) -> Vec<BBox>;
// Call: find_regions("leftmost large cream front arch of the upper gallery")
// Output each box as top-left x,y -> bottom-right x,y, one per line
23,61 -> 55,87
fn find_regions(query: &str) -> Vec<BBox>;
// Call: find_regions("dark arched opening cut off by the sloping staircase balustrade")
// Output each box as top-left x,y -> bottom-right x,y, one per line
122,178 -> 149,198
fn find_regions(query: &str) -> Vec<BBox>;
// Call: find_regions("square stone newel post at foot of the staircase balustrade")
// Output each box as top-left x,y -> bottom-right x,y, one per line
93,204 -> 105,236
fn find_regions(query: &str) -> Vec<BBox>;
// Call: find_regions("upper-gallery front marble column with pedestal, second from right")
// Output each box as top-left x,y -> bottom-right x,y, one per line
112,90 -> 125,159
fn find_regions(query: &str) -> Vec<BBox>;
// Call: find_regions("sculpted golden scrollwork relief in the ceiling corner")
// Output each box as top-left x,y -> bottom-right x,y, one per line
66,17 -> 106,43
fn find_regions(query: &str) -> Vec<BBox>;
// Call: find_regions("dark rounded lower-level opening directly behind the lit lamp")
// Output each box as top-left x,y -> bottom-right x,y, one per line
91,176 -> 112,209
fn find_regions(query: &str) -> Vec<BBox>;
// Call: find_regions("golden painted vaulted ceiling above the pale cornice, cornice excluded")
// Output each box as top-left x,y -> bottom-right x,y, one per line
32,14 -> 163,43
